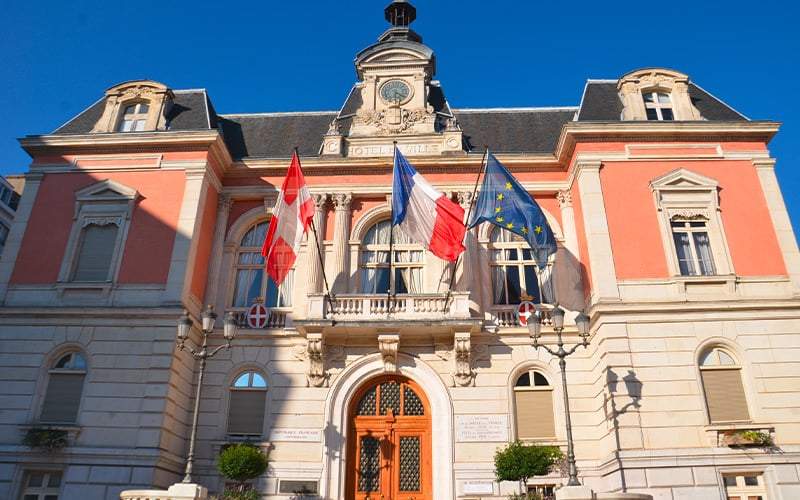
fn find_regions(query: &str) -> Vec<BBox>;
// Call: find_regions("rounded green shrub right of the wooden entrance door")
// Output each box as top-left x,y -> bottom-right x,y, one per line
494,440 -> 564,499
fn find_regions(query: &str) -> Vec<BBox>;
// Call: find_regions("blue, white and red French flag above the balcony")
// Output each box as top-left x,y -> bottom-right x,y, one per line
392,148 -> 467,261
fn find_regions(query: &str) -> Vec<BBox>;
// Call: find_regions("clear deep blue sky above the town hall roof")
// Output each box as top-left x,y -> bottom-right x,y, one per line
0,0 -> 800,244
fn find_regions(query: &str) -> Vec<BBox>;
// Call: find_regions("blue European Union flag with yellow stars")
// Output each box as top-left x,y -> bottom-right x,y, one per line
469,153 -> 556,269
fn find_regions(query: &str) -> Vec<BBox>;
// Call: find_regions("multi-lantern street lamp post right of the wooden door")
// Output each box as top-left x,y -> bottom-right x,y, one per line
527,306 -> 589,486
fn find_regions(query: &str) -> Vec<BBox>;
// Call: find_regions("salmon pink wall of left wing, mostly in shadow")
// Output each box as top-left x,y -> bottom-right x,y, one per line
11,171 -> 184,284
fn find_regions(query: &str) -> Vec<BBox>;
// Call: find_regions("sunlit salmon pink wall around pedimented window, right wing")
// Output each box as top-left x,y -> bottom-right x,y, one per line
600,161 -> 786,279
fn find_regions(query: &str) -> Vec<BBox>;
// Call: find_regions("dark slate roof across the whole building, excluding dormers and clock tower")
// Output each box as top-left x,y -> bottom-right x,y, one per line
48,75 -> 747,159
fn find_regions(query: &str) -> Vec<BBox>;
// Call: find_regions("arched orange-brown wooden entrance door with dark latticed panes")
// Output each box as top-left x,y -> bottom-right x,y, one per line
347,376 -> 432,500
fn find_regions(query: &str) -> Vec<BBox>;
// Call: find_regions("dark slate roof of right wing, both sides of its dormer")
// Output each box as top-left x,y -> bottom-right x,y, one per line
578,80 -> 747,122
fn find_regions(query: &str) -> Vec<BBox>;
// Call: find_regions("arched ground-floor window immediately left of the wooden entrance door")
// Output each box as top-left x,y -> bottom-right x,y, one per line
228,371 -> 267,436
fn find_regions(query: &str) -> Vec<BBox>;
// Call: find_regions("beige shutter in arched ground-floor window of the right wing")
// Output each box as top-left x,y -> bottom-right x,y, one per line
701,370 -> 750,422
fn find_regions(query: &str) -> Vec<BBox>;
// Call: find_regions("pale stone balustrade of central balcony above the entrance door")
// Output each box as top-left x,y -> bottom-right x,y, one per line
308,292 -> 470,321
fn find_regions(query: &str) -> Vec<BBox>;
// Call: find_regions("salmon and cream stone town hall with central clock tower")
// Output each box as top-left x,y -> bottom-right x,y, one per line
0,0 -> 800,500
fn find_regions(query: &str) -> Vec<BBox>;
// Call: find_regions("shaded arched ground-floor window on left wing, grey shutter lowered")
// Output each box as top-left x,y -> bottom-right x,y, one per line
39,352 -> 86,424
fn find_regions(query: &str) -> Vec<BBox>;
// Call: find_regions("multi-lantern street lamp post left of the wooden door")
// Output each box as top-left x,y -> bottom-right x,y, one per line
177,305 -> 236,483
